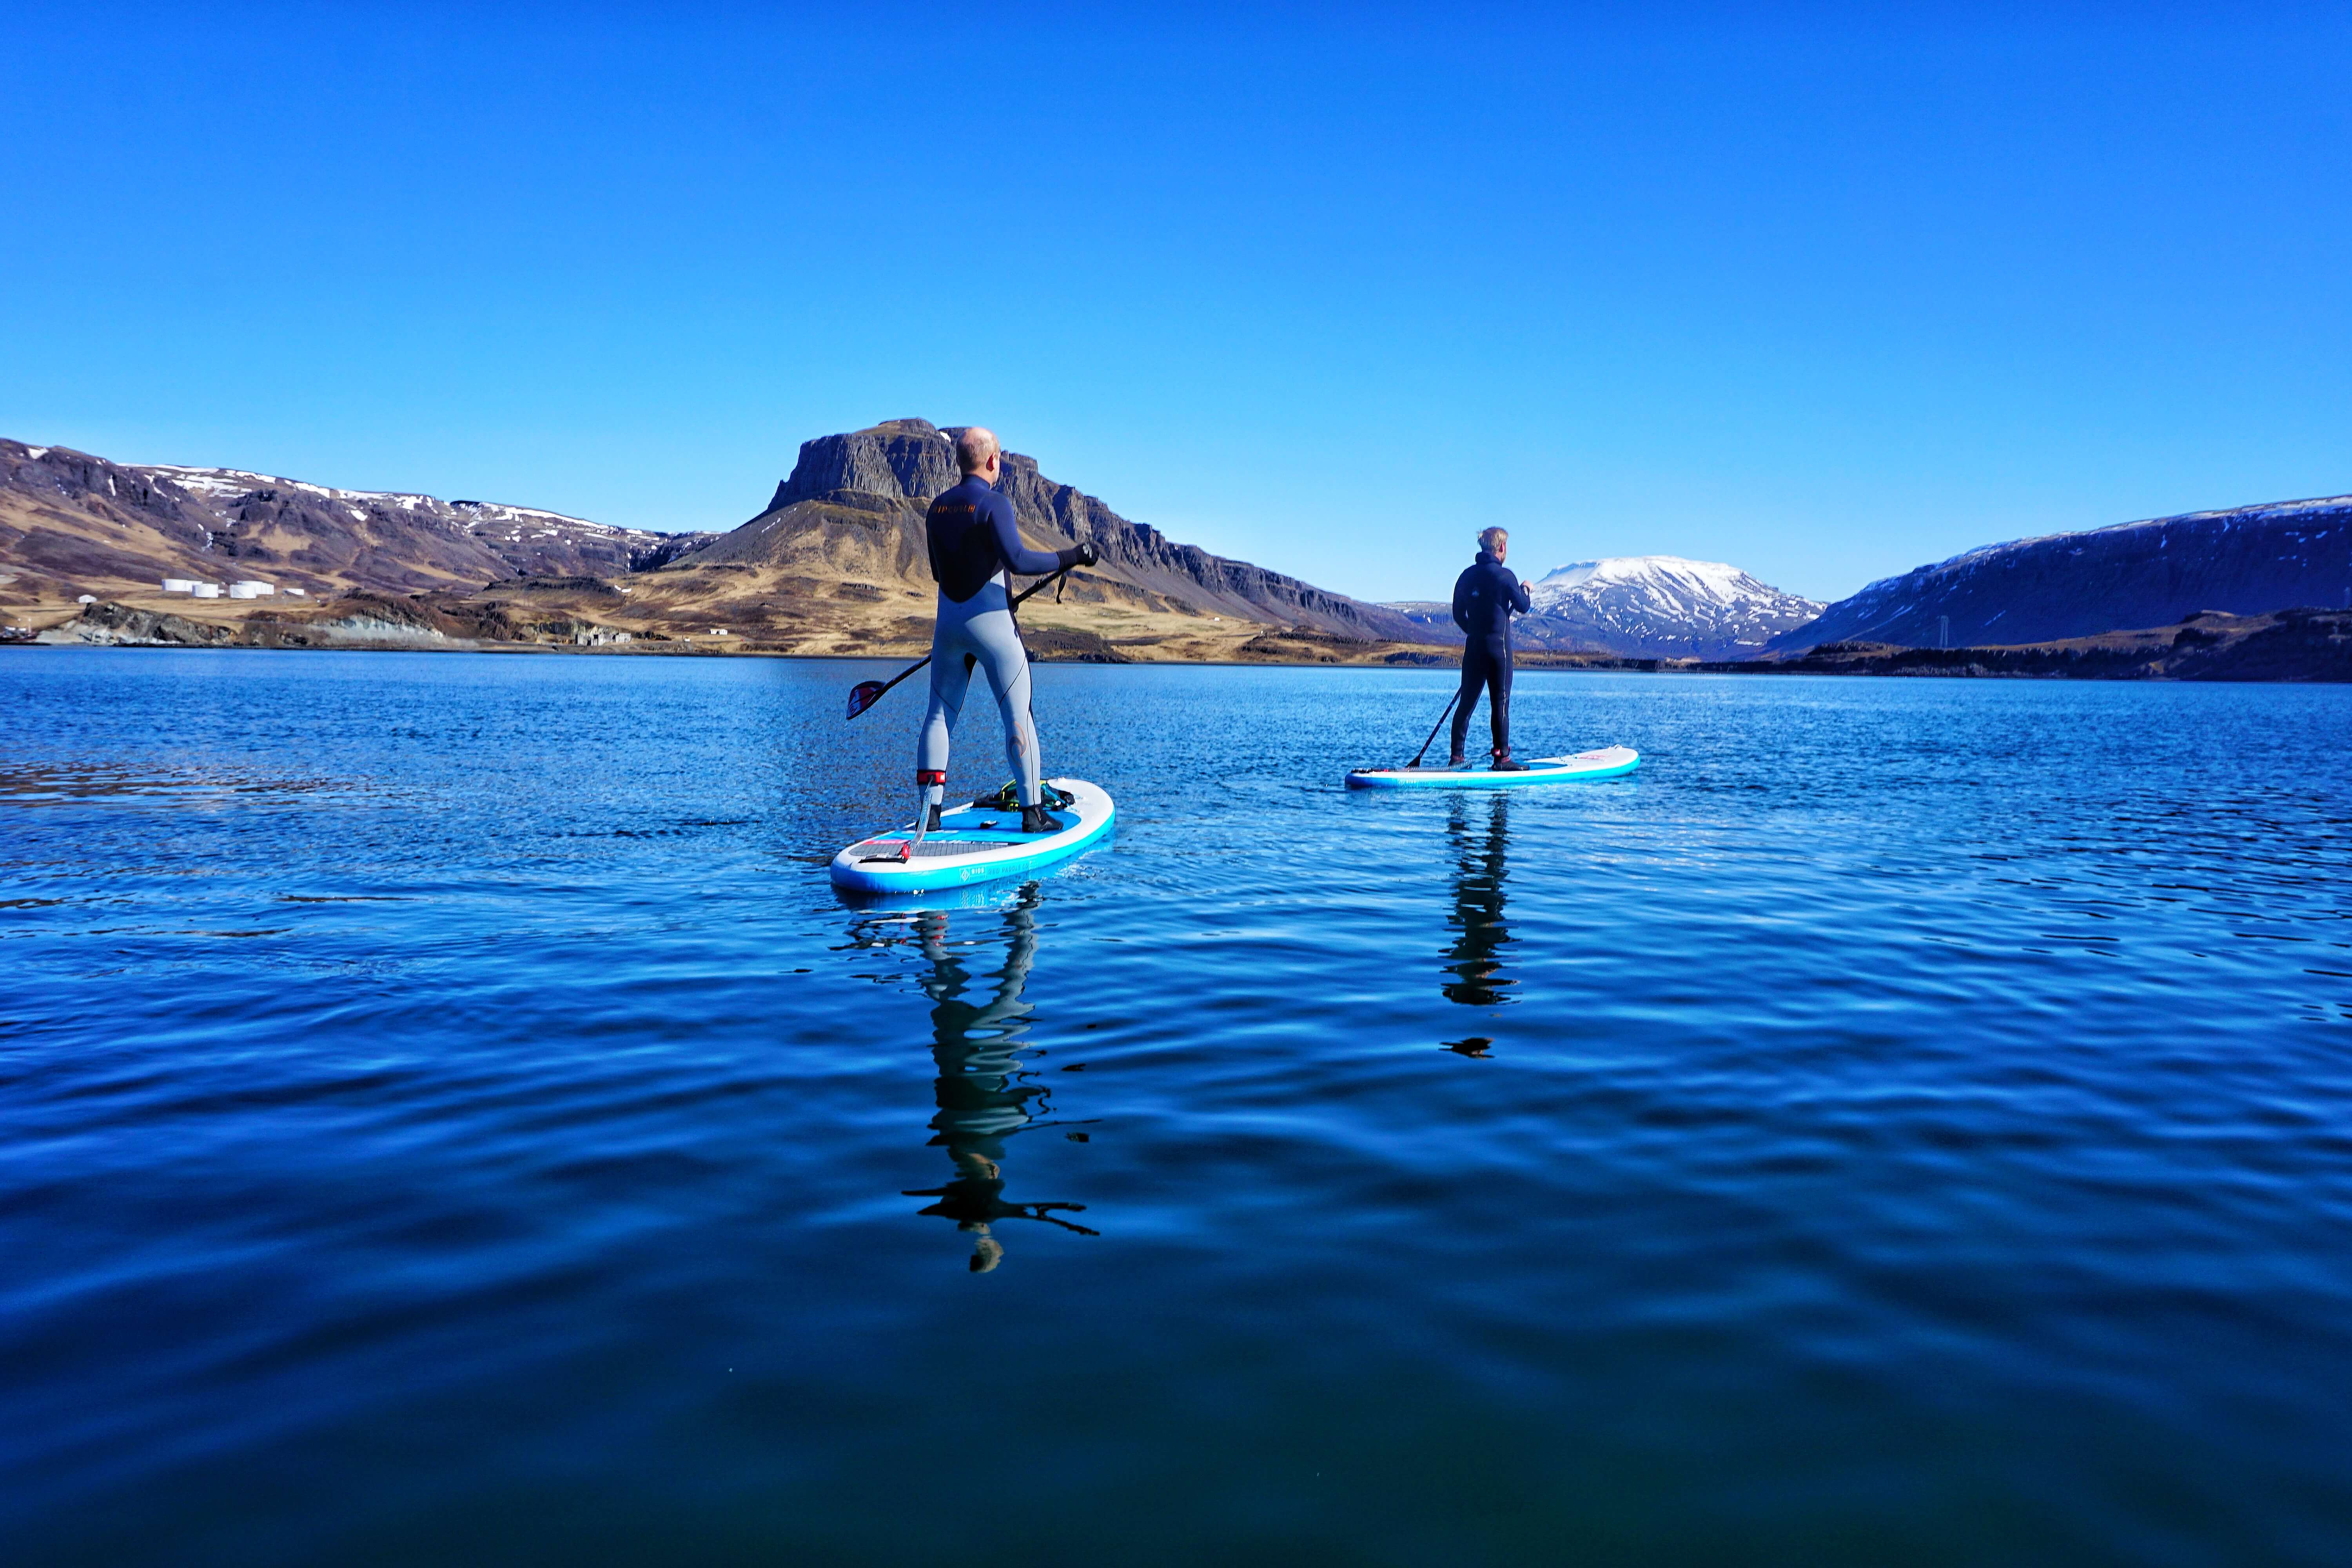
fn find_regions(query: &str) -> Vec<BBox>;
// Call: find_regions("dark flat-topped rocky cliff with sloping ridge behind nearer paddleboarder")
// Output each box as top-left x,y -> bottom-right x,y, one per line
682,418 -> 1423,642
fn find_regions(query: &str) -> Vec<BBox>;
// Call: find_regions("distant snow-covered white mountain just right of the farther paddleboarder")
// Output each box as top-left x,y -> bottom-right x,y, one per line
1522,555 -> 1823,658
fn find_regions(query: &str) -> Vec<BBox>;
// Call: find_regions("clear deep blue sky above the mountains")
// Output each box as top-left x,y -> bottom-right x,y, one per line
0,2 -> 2352,599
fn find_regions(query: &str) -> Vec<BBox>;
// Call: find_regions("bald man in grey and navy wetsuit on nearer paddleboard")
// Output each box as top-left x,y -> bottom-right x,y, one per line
915,425 -> 1101,832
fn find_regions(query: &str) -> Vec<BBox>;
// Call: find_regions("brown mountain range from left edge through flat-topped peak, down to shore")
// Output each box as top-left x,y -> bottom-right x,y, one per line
0,418 -> 1428,663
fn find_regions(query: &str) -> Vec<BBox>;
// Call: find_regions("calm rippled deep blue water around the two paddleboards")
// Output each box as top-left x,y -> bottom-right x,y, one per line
0,649 -> 2352,1568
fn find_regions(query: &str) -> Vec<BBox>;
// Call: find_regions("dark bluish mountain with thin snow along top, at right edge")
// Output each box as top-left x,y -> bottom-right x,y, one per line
1771,496 -> 2352,651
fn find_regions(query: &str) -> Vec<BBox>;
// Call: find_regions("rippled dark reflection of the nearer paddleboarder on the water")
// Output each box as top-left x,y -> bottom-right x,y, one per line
884,884 -> 1096,1274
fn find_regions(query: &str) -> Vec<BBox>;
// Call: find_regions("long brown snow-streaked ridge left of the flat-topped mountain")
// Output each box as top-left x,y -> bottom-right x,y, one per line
0,439 -> 710,599
